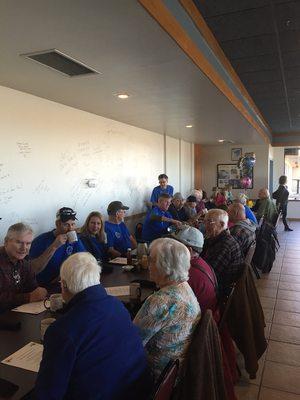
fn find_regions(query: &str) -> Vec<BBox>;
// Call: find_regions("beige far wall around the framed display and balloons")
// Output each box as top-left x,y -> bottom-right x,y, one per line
200,144 -> 269,198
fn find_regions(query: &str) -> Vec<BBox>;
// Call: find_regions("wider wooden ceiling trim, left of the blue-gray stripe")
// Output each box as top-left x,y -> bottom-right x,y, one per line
139,0 -> 270,144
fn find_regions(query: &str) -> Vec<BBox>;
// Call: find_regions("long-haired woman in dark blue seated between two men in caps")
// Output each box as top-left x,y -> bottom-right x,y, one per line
80,211 -> 107,261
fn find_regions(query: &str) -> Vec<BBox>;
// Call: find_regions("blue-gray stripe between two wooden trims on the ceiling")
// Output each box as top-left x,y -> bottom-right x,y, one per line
162,0 -> 271,137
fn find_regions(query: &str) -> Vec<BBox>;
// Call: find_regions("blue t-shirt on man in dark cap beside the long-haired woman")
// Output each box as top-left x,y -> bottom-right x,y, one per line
104,221 -> 131,255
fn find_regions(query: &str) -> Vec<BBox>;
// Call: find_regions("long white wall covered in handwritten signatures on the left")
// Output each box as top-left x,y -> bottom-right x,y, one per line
0,87 -> 193,241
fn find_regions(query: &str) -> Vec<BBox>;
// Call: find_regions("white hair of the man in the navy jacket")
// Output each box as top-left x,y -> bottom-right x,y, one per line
60,252 -> 101,295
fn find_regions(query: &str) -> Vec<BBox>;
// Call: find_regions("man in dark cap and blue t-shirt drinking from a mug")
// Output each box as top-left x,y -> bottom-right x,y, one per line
29,207 -> 85,287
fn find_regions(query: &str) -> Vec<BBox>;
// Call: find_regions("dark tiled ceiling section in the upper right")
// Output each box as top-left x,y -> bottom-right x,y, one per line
194,0 -> 300,135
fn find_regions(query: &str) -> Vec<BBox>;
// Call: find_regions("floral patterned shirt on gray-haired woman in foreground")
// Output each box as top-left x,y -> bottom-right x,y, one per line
134,282 -> 201,380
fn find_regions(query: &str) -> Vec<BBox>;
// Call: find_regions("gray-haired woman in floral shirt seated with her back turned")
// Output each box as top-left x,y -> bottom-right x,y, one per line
134,238 -> 200,380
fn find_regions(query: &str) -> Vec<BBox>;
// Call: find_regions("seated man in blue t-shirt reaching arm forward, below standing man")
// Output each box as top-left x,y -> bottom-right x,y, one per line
142,193 -> 181,242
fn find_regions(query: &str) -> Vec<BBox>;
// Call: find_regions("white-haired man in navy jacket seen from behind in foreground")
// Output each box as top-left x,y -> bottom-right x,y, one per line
34,253 -> 151,400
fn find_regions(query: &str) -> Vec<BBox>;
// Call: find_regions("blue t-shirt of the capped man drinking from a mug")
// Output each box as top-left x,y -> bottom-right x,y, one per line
29,230 -> 86,286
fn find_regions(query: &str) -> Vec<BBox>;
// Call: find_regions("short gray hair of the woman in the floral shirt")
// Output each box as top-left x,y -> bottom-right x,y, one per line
150,238 -> 191,282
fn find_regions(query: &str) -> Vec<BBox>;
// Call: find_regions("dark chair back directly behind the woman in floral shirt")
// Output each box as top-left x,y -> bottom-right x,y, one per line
152,360 -> 179,400
